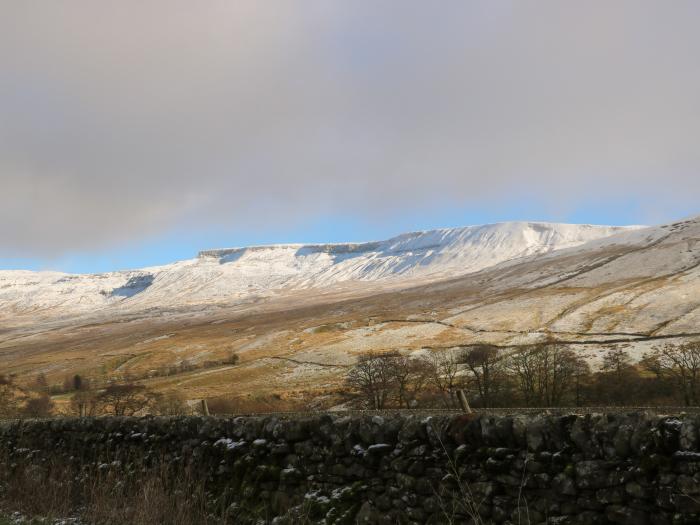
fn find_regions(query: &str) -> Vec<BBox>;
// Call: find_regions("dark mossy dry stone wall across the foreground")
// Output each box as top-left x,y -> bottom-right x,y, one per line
0,413 -> 700,525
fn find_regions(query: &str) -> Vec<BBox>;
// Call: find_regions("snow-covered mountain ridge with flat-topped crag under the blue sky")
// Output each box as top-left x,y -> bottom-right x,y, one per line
0,222 -> 634,320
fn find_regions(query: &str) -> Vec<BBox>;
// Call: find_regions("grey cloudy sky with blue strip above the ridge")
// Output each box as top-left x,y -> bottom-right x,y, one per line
0,0 -> 700,272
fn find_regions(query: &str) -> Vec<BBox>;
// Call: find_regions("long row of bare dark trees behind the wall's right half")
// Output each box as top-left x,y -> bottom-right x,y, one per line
345,341 -> 700,409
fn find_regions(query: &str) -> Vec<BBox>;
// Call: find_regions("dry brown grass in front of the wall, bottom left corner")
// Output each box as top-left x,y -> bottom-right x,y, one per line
0,450 -> 221,525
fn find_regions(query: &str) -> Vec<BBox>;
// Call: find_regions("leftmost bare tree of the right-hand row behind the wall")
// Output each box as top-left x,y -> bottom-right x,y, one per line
346,352 -> 396,410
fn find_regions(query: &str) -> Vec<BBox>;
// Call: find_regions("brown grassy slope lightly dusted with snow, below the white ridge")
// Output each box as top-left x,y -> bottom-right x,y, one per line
0,215 -> 700,399
